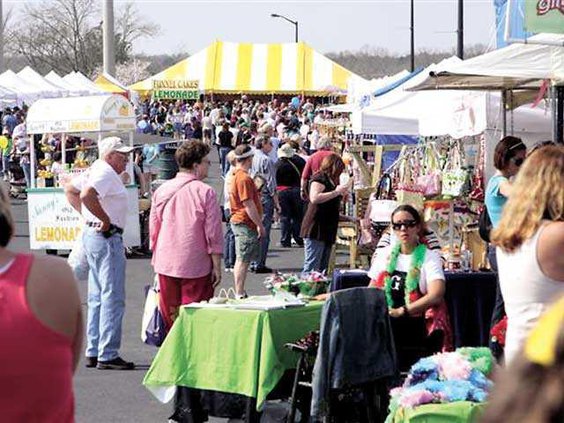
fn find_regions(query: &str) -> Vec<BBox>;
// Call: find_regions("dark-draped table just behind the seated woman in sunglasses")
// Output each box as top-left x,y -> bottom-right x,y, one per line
331,270 -> 497,348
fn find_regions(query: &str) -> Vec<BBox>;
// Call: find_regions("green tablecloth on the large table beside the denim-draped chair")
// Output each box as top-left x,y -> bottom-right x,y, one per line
143,302 -> 323,409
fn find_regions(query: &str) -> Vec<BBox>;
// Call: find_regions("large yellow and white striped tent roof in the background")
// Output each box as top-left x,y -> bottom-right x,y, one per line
129,41 -> 362,96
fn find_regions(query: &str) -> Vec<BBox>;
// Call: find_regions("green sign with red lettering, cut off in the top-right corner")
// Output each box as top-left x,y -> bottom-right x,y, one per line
525,0 -> 564,33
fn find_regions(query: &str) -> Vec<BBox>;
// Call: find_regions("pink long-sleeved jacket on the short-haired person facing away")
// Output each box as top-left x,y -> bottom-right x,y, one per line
149,172 -> 223,278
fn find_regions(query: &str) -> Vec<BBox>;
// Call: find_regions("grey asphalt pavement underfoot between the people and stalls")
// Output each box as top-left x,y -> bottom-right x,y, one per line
10,150 -> 303,423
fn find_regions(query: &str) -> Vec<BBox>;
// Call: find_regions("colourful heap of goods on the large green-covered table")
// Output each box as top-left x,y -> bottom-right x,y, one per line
264,272 -> 329,298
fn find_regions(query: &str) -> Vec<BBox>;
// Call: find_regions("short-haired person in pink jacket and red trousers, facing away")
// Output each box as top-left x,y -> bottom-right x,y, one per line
149,140 -> 223,330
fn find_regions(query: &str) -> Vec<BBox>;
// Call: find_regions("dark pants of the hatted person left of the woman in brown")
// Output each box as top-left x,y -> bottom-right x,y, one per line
278,187 -> 304,247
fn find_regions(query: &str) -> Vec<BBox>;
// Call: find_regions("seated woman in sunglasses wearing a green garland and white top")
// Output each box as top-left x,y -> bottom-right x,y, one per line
368,205 -> 451,370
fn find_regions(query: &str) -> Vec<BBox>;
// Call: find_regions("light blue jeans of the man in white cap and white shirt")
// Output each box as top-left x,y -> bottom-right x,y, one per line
82,227 -> 125,361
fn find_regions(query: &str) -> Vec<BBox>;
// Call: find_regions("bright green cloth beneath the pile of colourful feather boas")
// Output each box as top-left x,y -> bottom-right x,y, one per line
387,401 -> 485,423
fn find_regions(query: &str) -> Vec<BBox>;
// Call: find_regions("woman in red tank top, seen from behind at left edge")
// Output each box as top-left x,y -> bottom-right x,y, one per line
0,183 -> 83,423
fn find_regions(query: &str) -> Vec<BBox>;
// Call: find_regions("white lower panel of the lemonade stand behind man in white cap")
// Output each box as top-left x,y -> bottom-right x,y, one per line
27,187 -> 141,250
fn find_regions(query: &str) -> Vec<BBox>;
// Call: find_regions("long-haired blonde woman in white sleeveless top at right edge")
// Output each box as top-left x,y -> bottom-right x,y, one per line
492,146 -> 564,362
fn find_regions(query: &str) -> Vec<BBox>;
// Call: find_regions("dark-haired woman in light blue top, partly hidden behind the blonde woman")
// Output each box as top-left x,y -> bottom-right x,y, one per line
485,136 -> 527,358
